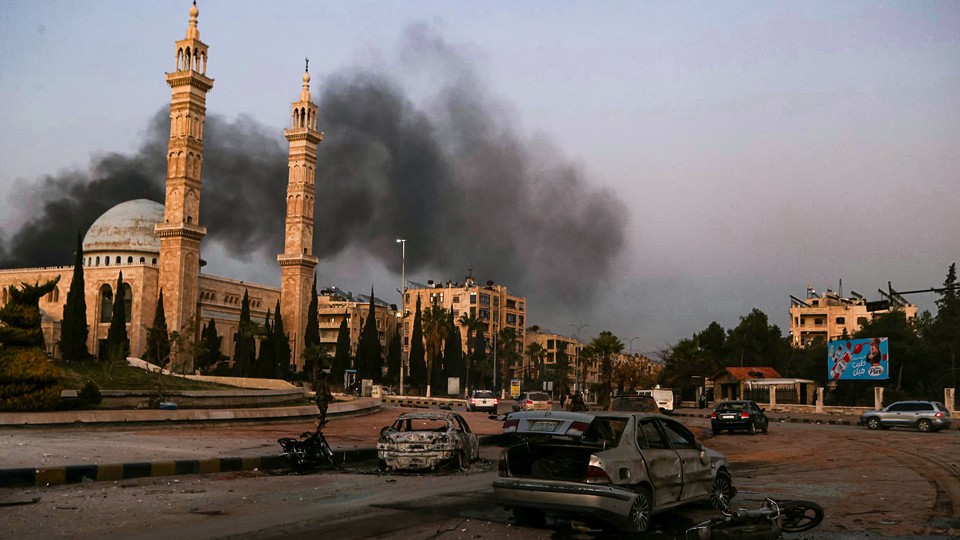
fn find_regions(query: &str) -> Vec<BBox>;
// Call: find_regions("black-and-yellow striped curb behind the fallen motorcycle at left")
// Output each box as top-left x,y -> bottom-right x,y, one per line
0,448 -> 377,488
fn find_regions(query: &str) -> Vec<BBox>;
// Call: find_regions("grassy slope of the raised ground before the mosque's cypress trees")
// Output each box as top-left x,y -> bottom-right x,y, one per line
54,360 -> 236,391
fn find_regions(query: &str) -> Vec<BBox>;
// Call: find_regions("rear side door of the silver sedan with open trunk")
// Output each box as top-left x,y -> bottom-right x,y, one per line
636,418 -> 683,506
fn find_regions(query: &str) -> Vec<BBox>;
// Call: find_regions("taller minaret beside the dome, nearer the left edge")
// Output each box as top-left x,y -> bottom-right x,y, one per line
156,2 -> 213,342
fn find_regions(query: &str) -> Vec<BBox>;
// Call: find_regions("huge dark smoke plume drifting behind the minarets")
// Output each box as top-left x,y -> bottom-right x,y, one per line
0,26 -> 627,306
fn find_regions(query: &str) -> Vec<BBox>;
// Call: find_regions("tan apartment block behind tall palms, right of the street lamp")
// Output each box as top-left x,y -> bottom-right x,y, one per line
401,277 -> 527,364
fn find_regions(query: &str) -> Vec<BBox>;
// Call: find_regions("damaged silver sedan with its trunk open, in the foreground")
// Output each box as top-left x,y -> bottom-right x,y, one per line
493,411 -> 736,532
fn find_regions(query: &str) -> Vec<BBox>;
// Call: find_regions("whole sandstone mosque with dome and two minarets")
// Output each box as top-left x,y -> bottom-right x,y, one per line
0,5 -> 323,367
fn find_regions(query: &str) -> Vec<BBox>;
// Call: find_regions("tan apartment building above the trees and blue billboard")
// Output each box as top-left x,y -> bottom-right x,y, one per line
790,286 -> 917,347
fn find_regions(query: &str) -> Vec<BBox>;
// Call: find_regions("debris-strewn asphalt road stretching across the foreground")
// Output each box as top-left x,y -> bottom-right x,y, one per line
0,412 -> 960,540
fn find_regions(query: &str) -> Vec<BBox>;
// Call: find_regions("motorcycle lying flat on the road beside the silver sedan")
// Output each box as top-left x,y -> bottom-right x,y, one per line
686,498 -> 823,540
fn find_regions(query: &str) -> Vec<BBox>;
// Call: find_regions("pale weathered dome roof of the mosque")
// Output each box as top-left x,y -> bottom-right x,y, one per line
83,199 -> 163,254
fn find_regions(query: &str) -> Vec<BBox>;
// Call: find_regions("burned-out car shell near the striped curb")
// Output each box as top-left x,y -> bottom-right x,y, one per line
377,411 -> 480,471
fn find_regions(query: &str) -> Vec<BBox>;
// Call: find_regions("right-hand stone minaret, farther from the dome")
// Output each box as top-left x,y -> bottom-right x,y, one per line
277,60 -> 323,369
